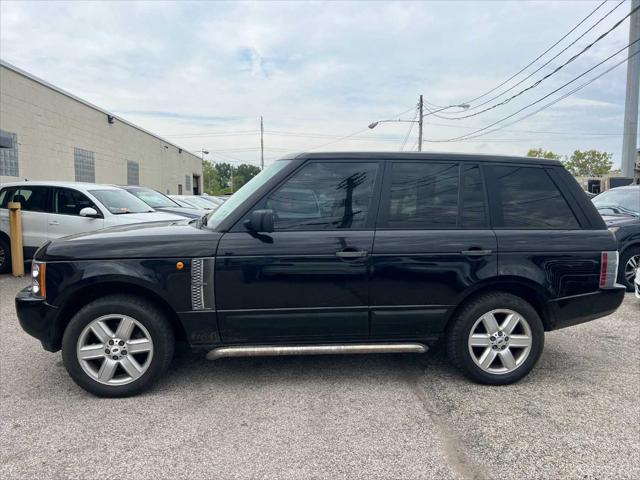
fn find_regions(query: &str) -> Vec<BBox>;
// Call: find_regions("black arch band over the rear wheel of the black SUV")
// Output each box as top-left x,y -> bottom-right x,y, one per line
446,276 -> 555,331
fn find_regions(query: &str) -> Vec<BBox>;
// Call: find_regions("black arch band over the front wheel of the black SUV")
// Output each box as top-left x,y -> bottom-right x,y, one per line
52,281 -> 187,350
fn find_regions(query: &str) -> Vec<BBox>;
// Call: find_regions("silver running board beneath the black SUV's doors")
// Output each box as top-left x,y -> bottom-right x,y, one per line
207,343 -> 429,360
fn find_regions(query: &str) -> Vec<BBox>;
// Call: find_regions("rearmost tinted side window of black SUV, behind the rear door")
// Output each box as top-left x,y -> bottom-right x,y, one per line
489,166 -> 578,229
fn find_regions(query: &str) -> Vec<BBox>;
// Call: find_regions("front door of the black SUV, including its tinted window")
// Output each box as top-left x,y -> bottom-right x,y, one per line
216,160 -> 381,343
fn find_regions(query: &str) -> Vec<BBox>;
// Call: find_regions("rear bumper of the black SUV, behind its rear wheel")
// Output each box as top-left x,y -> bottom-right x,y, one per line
551,286 -> 626,330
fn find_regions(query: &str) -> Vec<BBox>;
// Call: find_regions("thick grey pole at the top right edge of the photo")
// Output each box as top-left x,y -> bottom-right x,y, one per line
621,0 -> 640,178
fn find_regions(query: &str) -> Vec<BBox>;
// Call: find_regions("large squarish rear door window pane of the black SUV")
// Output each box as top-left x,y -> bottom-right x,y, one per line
382,162 -> 459,229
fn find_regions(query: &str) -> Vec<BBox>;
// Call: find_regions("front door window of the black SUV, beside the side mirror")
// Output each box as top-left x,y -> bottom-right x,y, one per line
263,162 -> 378,230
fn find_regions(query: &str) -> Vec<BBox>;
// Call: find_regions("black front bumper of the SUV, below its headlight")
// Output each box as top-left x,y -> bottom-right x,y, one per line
16,287 -> 60,352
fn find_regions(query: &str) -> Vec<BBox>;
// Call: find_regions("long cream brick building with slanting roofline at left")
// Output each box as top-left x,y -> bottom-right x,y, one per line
0,61 -> 202,195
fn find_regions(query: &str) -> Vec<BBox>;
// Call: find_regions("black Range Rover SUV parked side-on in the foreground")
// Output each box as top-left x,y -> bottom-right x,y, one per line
16,153 -> 624,397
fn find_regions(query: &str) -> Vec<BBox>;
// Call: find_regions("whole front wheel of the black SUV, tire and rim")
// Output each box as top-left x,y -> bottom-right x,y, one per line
62,295 -> 175,397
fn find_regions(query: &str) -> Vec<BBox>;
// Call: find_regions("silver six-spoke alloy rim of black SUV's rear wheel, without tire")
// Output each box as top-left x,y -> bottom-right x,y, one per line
468,309 -> 533,375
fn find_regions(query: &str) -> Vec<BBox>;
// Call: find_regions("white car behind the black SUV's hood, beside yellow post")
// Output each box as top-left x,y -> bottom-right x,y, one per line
0,181 -> 184,273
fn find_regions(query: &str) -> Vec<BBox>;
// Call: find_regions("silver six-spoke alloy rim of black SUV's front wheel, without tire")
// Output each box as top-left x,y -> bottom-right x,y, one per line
76,314 -> 153,386
